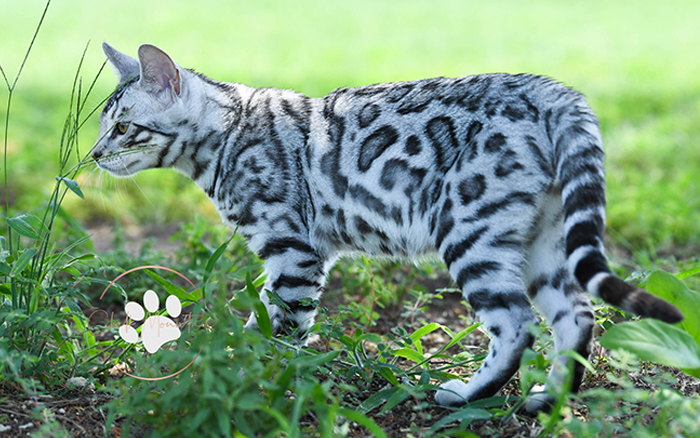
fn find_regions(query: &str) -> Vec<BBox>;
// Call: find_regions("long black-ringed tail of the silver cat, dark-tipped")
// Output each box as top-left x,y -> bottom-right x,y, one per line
547,95 -> 683,323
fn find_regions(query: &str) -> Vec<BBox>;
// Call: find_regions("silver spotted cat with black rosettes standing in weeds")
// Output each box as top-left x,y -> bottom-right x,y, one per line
92,43 -> 683,412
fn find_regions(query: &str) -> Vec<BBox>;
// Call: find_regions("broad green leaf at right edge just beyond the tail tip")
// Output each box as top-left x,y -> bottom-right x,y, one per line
646,271 -> 700,345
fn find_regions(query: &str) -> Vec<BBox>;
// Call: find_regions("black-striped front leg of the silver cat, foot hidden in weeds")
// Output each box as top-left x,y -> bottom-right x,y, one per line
246,237 -> 326,342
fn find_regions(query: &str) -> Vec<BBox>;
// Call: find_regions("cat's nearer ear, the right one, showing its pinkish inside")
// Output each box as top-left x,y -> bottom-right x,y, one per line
139,44 -> 181,95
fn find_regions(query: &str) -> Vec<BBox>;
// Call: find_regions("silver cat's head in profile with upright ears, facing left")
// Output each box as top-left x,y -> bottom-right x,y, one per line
92,43 -> 189,176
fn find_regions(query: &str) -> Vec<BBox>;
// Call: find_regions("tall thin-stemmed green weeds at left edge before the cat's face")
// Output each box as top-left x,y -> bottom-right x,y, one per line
0,2 -> 107,396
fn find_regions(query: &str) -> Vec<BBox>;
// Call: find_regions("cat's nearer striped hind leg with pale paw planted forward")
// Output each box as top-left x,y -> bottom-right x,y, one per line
435,224 -> 537,406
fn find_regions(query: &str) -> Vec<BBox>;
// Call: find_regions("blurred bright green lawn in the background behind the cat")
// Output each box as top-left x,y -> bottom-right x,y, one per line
0,0 -> 700,255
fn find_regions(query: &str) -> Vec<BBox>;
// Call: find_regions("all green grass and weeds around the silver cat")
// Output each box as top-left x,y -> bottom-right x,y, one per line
0,0 -> 700,437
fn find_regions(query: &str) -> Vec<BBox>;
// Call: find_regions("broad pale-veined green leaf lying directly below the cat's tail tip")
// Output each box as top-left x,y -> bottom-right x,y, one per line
600,319 -> 700,370
